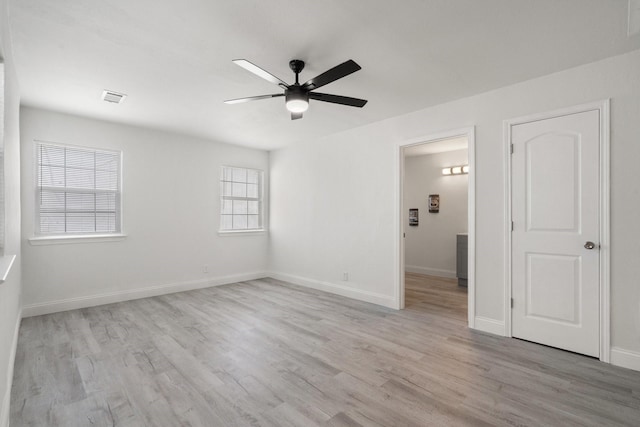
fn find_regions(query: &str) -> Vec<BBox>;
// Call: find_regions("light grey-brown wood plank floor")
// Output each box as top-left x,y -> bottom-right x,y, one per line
11,275 -> 640,427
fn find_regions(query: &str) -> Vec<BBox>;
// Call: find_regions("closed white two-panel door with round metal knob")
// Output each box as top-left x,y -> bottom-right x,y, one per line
511,110 -> 600,357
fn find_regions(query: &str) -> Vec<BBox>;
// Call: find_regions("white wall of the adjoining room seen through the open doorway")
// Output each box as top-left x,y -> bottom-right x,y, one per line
404,149 -> 469,277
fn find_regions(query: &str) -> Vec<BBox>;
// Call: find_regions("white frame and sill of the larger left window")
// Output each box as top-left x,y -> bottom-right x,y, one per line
29,140 -> 126,239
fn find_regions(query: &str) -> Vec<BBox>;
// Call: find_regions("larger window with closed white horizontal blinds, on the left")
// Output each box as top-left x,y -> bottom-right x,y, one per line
36,142 -> 122,235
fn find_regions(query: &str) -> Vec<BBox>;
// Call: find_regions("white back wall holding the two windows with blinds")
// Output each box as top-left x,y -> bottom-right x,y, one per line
21,108 -> 269,315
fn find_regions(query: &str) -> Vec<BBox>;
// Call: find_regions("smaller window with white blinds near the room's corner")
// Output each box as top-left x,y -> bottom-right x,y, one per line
220,166 -> 262,231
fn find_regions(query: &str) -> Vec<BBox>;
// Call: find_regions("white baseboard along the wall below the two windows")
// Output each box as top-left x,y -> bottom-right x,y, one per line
22,272 -> 267,317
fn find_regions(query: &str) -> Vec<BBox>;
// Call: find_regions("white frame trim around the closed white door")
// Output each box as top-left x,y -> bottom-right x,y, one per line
503,99 -> 611,363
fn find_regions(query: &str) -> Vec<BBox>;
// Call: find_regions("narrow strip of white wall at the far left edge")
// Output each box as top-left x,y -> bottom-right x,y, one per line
0,0 -> 22,426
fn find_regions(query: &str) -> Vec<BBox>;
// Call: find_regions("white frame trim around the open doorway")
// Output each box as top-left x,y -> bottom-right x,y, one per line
394,126 -> 476,328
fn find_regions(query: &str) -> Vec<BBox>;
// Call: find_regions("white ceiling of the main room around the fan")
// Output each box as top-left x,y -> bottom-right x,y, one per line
9,0 -> 640,150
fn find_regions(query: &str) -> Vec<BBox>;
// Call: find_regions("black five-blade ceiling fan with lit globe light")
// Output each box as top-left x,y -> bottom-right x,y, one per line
224,59 -> 367,120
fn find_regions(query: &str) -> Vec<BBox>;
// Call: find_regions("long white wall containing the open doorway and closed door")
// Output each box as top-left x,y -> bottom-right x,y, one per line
270,51 -> 640,369
